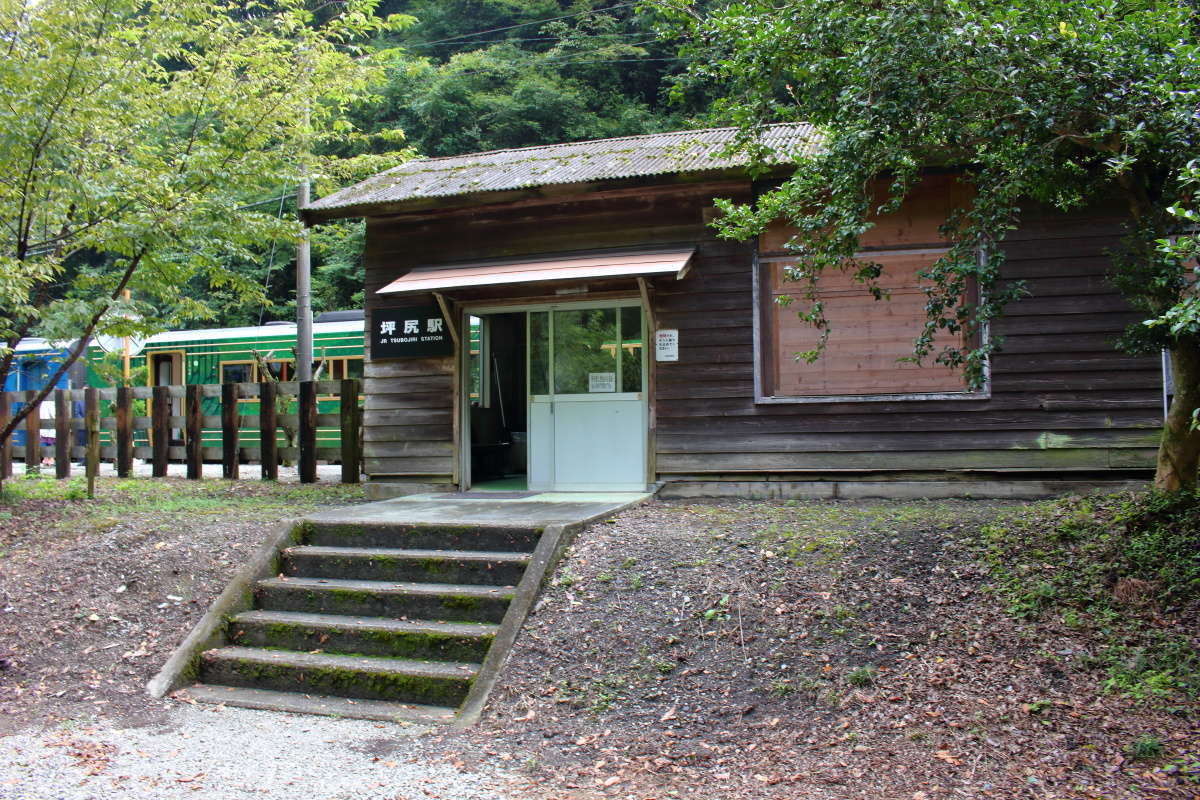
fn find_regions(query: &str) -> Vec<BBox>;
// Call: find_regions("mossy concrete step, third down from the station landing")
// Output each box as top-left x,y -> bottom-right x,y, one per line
254,577 -> 514,622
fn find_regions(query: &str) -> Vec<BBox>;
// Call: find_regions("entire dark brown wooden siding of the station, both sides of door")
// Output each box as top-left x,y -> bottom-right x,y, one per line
364,181 -> 1162,482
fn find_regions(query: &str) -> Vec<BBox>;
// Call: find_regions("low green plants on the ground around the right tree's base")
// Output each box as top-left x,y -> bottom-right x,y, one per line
983,492 -> 1200,698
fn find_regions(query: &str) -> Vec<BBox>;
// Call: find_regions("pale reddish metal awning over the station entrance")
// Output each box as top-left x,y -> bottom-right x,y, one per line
379,247 -> 696,294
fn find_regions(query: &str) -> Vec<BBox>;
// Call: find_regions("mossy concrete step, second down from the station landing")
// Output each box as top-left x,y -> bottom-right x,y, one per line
283,545 -> 529,587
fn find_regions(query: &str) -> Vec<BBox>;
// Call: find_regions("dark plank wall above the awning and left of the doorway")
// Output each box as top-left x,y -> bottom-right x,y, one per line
362,181 -> 750,482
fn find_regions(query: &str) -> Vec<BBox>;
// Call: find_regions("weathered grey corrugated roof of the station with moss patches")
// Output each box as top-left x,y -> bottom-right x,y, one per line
308,122 -> 821,217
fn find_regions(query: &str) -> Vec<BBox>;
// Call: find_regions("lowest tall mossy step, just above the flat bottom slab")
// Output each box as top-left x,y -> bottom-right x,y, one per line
200,646 -> 479,708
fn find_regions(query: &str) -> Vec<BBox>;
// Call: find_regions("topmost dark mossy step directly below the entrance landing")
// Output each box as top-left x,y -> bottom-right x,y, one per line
304,519 -> 541,553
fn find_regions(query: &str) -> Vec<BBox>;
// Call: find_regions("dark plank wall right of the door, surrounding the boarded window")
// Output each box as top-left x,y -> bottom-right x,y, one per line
658,206 -> 1162,480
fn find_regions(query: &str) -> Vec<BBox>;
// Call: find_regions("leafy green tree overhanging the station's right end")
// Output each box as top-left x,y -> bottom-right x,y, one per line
650,0 -> 1200,489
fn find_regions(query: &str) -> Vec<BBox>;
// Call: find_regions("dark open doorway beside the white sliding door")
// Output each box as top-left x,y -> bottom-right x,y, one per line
467,312 -> 529,492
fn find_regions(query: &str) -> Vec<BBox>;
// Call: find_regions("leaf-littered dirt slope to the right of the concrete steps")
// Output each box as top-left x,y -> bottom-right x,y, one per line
420,501 -> 1200,800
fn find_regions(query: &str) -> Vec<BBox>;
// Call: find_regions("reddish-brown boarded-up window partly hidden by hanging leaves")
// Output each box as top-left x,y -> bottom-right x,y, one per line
762,248 -> 966,397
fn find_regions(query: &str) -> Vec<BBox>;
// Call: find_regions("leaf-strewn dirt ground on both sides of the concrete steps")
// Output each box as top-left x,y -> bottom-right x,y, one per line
0,481 -> 1200,800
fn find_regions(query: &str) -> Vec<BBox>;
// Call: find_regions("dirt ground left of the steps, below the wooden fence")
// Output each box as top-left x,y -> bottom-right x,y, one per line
0,479 -> 362,735
